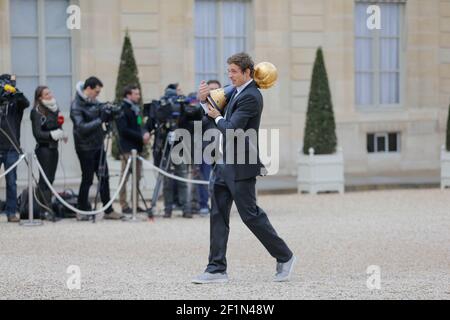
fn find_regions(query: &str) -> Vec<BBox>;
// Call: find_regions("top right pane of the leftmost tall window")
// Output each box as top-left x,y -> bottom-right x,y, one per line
45,0 -> 70,35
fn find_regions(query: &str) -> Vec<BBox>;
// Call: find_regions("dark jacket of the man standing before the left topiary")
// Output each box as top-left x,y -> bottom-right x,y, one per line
117,100 -> 144,154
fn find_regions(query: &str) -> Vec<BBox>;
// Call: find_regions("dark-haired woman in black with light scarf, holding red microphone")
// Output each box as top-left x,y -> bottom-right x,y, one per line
30,86 -> 67,219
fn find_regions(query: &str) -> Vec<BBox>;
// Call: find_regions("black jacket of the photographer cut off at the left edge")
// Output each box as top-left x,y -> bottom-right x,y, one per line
0,92 -> 30,152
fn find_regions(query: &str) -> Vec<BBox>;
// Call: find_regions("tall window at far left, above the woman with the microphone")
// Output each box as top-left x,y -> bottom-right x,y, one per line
10,0 -> 72,110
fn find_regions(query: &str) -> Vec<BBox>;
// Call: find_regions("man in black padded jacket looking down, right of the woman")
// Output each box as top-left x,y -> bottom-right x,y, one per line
70,77 -> 122,220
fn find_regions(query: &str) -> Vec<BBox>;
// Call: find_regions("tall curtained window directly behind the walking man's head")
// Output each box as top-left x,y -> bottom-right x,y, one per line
195,0 -> 250,84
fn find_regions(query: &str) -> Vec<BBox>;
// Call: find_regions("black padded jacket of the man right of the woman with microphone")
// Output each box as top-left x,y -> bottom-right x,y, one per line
70,83 -> 105,151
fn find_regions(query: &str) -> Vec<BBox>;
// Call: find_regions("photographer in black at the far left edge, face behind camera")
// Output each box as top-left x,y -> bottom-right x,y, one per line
0,74 -> 30,223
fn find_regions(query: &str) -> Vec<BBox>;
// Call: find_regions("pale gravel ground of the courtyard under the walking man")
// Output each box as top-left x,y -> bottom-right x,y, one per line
0,189 -> 450,300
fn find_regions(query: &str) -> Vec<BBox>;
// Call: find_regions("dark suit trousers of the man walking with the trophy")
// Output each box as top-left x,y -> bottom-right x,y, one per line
206,165 -> 292,273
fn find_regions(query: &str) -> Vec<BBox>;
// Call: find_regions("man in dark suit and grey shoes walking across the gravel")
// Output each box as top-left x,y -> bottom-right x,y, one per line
192,53 -> 296,284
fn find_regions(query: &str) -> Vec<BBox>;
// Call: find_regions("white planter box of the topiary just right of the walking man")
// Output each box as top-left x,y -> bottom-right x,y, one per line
297,148 -> 345,194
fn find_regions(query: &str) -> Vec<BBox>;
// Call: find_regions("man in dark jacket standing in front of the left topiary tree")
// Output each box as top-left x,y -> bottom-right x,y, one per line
117,85 -> 150,214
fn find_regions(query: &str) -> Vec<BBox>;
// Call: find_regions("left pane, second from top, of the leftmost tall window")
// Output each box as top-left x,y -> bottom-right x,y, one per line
11,38 -> 39,76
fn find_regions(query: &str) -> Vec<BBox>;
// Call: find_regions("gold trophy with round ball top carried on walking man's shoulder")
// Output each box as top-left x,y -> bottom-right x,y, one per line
207,62 -> 278,112
